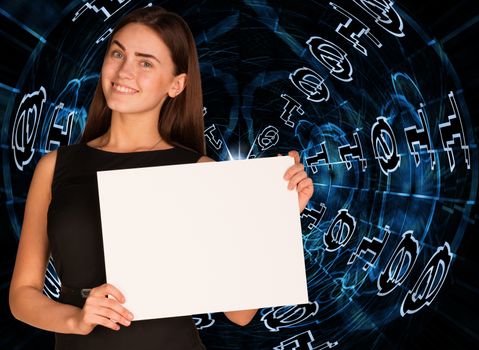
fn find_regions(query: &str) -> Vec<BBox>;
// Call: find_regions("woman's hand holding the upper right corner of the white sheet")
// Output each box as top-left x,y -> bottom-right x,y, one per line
284,151 -> 314,213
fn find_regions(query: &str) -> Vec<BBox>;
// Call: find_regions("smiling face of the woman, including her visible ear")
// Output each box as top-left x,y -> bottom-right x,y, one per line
101,23 -> 184,115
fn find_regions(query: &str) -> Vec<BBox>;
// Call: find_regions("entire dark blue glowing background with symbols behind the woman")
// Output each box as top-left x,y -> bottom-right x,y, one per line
0,0 -> 479,349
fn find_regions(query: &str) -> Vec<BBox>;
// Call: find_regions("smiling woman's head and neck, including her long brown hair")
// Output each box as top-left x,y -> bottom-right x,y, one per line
81,8 -> 205,154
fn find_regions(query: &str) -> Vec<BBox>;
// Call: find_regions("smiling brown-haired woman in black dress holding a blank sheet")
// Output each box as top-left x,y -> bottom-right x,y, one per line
10,8 -> 313,349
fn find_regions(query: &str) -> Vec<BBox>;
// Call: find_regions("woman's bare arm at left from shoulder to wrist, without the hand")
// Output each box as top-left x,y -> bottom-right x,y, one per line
9,151 -> 79,333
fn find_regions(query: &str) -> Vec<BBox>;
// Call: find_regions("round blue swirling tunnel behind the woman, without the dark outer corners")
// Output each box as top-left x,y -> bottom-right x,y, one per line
1,0 -> 478,349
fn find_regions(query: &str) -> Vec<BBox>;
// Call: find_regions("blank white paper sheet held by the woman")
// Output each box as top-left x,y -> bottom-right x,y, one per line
98,156 -> 308,320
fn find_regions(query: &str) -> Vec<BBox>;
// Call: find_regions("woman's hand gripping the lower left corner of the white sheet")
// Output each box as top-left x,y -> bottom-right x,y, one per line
75,283 -> 133,335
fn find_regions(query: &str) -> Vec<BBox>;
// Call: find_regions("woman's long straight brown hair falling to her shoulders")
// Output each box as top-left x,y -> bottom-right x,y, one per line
80,6 -> 206,155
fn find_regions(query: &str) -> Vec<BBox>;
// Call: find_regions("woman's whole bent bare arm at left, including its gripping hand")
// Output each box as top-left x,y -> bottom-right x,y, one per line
9,151 -> 133,334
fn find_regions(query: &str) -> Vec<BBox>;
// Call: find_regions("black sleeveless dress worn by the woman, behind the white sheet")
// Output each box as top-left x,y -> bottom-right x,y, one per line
48,144 -> 205,350
